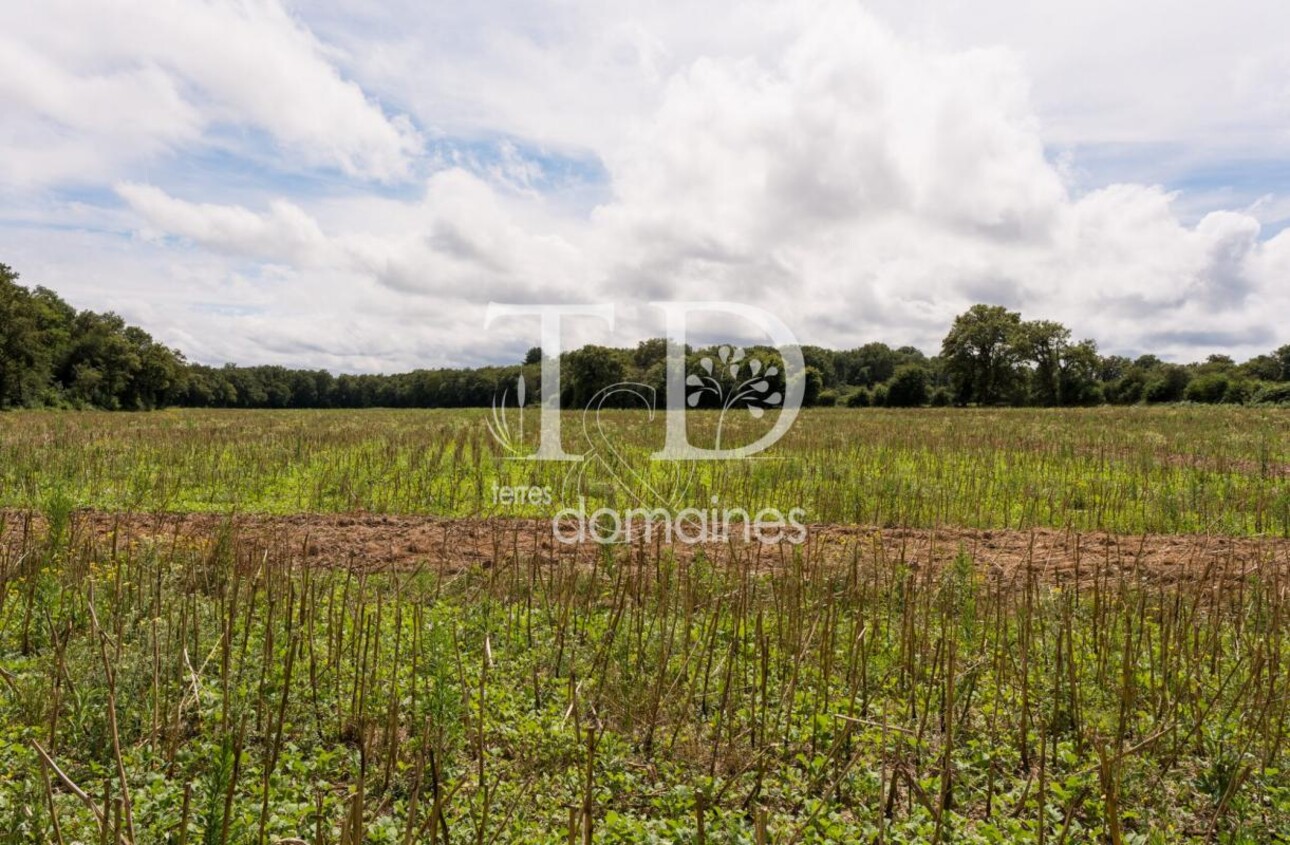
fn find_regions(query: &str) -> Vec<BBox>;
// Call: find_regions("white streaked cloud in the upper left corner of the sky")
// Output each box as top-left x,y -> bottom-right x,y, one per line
0,0 -> 419,187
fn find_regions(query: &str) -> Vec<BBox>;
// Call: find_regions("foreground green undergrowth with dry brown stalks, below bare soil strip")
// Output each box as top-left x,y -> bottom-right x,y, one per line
0,505 -> 1290,845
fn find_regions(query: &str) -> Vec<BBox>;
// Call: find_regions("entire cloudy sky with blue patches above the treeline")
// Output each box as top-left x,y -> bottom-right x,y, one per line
0,0 -> 1290,372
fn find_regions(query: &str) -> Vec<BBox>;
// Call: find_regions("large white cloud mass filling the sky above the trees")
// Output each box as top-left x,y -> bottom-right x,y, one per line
0,0 -> 1290,369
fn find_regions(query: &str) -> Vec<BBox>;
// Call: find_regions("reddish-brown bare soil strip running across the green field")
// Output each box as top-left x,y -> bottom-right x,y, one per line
0,510 -> 1290,582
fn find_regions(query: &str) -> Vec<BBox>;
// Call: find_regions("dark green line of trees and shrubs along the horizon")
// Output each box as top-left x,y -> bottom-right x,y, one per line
0,264 -> 1290,410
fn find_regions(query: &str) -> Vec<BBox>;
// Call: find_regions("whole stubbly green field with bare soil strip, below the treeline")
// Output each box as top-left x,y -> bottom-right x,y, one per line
0,408 -> 1290,845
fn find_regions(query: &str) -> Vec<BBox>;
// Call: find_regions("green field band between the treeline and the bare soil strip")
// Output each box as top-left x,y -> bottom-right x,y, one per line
0,406 -> 1290,537
